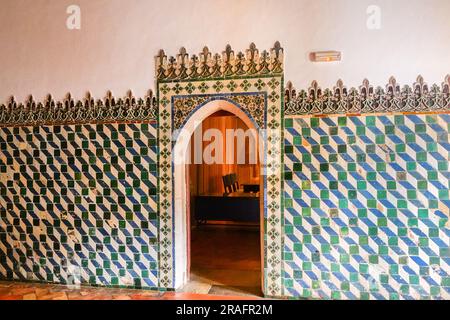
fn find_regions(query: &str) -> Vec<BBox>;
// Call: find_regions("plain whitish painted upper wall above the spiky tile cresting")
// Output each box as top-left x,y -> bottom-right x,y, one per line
0,0 -> 450,102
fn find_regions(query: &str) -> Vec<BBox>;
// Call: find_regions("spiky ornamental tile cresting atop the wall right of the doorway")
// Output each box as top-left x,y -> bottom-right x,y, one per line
284,76 -> 450,115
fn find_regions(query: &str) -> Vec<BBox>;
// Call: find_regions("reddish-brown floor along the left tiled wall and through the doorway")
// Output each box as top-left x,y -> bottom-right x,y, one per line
0,226 -> 262,300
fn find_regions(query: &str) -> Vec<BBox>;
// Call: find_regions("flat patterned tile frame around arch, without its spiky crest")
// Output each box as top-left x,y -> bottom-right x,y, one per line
159,75 -> 283,296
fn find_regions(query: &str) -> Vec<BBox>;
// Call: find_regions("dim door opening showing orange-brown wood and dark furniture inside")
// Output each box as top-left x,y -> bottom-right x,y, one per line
184,111 -> 264,296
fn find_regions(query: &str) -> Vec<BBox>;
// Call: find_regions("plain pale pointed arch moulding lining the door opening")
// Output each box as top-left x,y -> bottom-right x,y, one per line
173,99 -> 266,290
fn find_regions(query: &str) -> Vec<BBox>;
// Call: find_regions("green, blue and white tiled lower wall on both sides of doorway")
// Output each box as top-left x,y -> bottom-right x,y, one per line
0,115 -> 450,299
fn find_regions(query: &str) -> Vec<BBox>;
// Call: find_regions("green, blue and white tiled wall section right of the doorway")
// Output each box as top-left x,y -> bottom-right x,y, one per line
284,114 -> 450,299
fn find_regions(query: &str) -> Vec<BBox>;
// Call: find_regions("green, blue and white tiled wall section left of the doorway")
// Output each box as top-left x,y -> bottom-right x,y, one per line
0,124 -> 158,288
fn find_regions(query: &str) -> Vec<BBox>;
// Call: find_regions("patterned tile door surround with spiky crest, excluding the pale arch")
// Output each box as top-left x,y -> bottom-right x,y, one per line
156,42 -> 284,296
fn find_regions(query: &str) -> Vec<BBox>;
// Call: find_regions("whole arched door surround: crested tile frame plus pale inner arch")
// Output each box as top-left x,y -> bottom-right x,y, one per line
155,42 -> 286,297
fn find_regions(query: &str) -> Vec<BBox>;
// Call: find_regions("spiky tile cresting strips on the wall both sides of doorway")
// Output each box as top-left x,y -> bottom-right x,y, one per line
0,75 -> 450,126
